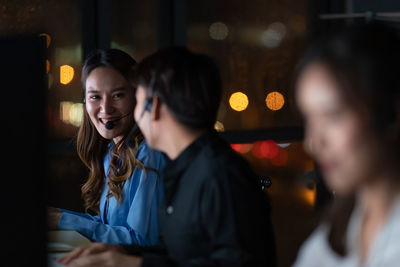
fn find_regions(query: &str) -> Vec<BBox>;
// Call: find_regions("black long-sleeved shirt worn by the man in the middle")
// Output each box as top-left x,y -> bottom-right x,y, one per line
125,131 -> 275,266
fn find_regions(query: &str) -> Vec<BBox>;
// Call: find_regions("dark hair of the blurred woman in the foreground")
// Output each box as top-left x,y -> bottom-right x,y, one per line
295,23 -> 400,255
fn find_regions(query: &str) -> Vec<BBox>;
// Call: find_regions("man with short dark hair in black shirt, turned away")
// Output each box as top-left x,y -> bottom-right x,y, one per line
61,47 -> 275,267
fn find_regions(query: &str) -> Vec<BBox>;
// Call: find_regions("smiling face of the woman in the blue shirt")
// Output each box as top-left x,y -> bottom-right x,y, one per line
85,67 -> 134,142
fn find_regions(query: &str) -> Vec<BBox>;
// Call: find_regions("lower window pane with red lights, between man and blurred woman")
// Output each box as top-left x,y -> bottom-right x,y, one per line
231,140 -> 324,266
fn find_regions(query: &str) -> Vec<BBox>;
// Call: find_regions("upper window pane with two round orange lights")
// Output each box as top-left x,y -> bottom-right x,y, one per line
187,0 -> 307,130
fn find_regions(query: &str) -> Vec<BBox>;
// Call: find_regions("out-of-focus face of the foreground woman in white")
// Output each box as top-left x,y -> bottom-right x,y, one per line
296,64 -> 378,194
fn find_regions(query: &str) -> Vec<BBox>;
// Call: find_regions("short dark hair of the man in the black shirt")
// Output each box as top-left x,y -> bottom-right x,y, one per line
135,47 -> 222,129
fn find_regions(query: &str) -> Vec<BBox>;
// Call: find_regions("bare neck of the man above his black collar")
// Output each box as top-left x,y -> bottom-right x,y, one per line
163,125 -> 206,160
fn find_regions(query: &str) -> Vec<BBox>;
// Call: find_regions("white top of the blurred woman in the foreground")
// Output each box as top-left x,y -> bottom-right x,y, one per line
293,198 -> 400,267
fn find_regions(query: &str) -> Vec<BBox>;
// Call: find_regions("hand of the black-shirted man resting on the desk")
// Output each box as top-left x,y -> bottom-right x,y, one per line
57,243 -> 125,266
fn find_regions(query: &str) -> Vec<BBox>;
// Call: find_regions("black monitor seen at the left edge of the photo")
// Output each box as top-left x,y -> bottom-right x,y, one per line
0,36 -> 47,266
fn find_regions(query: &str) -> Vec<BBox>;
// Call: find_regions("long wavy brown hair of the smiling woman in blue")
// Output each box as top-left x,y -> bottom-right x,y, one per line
77,49 -> 145,213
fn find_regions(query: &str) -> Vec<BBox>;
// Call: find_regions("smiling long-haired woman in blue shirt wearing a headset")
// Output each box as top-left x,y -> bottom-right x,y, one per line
49,49 -> 165,245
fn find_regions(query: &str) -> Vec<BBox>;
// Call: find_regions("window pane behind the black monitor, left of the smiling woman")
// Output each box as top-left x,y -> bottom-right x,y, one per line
0,0 -> 87,211
